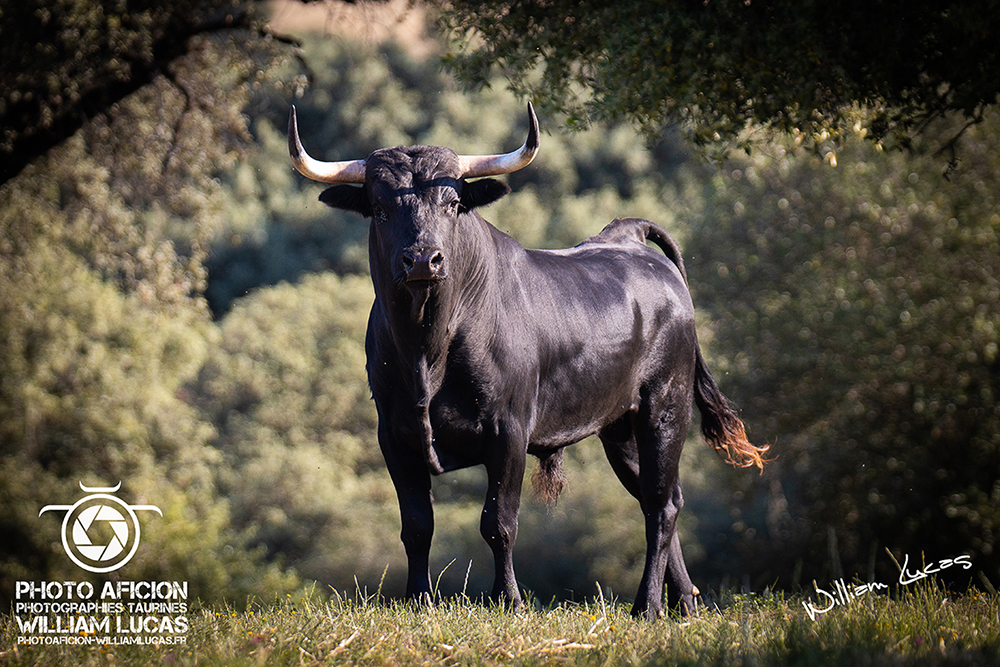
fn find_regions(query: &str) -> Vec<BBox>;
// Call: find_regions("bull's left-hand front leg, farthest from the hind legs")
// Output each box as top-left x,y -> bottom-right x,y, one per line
378,428 -> 434,601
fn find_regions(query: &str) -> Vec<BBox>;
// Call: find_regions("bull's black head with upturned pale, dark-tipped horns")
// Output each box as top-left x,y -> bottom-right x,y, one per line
288,102 -> 538,290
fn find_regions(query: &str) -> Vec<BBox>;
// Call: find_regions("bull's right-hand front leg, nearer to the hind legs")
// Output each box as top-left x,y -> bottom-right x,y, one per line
480,429 -> 527,610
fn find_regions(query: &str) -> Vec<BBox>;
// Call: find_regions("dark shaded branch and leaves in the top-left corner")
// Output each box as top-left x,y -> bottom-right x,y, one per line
0,0 -> 274,183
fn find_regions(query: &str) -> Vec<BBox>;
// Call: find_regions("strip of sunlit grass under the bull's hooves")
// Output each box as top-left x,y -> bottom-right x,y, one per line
0,584 -> 1000,667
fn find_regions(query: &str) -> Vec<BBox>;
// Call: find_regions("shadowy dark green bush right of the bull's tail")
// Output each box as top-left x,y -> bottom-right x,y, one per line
685,113 -> 1000,584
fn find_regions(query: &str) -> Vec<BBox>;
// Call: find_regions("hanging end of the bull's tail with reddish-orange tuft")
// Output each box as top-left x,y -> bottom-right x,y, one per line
694,348 -> 768,471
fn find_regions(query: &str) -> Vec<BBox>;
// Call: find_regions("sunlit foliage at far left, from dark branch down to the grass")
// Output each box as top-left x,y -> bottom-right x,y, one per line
0,20 -> 297,601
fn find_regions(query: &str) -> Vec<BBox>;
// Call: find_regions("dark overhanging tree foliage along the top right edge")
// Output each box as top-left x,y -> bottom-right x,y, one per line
441,0 -> 1000,162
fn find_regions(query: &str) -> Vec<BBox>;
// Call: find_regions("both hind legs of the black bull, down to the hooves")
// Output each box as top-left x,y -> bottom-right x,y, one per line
601,401 -> 694,619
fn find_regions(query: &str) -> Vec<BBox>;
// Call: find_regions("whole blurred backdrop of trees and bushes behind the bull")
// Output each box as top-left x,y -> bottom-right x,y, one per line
0,2 -> 1000,604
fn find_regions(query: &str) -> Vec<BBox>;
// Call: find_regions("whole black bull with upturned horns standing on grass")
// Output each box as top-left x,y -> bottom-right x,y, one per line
289,104 -> 766,618
